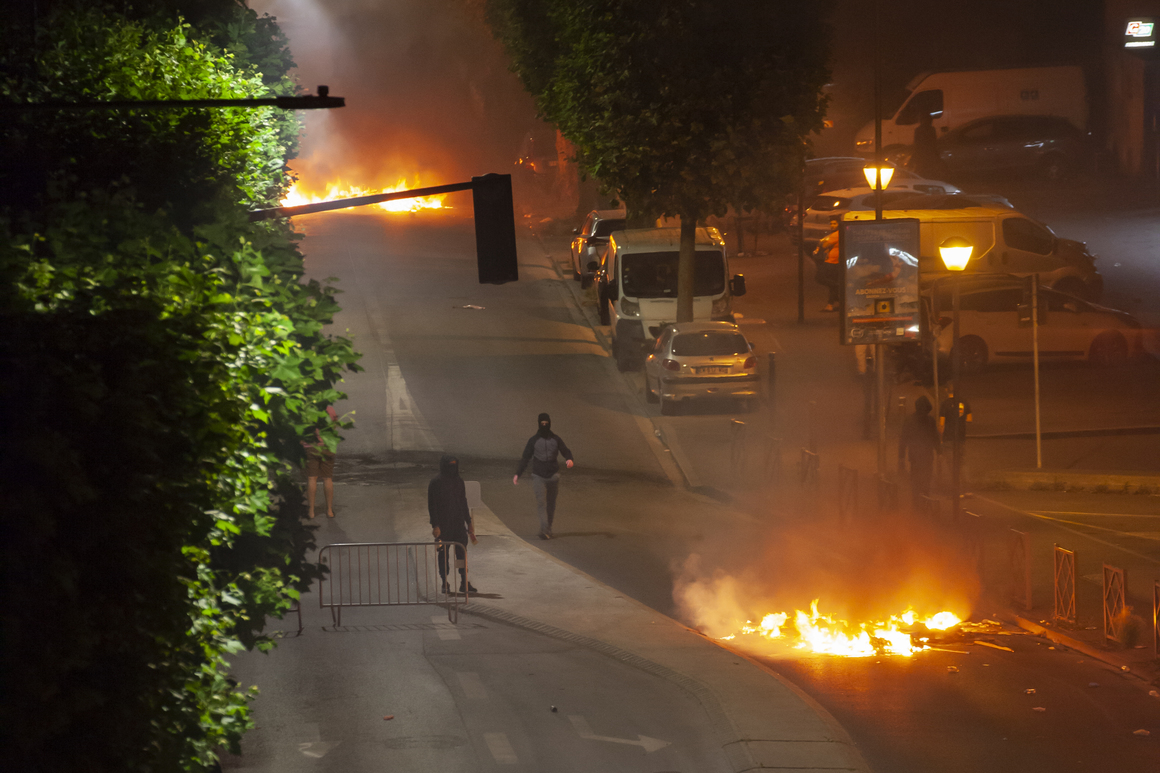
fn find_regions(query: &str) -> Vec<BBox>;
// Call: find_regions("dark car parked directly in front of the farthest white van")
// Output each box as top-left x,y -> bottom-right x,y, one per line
938,115 -> 1086,180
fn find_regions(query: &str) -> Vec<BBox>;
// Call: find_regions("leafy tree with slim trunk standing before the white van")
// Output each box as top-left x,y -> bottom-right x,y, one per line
486,0 -> 828,322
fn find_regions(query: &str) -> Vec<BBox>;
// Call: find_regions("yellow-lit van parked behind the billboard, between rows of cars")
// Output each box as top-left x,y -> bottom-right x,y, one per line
843,196 -> 1103,301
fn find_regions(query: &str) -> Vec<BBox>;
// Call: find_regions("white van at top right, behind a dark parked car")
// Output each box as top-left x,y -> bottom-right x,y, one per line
854,66 -> 1088,158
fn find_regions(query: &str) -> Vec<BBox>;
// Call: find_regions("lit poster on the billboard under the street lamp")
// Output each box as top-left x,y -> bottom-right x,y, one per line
839,218 -> 920,346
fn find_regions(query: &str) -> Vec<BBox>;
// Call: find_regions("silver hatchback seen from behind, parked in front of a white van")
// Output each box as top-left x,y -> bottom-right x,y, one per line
645,322 -> 761,416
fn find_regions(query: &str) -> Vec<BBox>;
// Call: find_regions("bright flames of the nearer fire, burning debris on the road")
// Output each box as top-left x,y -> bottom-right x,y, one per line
719,599 -> 962,658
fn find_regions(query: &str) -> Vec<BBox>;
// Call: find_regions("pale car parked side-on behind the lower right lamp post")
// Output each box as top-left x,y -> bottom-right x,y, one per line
923,276 -> 1143,373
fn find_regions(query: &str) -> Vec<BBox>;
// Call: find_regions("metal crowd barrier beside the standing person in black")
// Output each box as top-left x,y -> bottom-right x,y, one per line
318,542 -> 467,626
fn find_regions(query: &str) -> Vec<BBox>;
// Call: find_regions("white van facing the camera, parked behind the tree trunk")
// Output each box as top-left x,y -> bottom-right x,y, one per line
596,227 -> 745,370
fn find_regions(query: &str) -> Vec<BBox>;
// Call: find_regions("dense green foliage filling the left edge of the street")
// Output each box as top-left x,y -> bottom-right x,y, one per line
0,0 -> 357,771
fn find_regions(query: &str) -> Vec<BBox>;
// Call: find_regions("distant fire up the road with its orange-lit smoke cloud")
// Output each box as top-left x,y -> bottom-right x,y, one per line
252,0 -> 540,190
